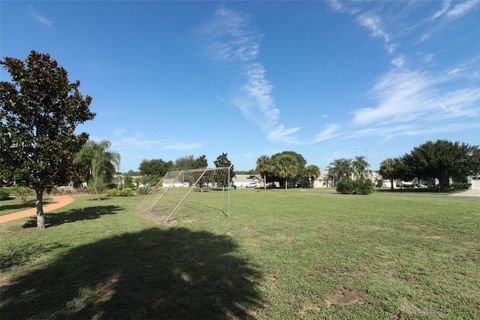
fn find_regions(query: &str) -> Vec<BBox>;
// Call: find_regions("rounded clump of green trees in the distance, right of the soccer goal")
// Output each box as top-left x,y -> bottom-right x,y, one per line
256,151 -> 320,190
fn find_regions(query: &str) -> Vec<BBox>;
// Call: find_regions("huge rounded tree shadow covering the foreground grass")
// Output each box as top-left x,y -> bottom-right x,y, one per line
0,228 -> 262,320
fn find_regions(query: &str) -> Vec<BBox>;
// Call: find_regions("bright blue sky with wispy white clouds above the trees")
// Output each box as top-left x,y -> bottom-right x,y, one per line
0,0 -> 480,171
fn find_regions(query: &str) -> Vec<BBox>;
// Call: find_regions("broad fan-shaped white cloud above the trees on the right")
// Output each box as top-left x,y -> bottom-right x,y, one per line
353,69 -> 480,125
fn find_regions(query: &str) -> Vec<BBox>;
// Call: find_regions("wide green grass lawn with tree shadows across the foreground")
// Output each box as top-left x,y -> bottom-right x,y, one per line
0,190 -> 480,320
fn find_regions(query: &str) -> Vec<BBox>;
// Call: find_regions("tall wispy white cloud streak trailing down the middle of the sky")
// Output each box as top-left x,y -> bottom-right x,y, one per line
203,8 -> 338,145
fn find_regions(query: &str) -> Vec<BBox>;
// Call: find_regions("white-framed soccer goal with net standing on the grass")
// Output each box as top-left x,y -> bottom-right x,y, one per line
138,167 -> 231,223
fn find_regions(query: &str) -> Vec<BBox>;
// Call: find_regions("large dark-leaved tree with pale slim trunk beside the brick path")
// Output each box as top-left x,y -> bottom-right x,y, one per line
0,51 -> 95,229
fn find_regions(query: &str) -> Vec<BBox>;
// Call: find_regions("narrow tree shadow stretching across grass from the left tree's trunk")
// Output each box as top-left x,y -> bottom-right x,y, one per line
22,205 -> 122,228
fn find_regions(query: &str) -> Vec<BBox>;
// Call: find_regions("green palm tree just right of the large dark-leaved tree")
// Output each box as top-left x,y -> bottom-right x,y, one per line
75,140 -> 120,194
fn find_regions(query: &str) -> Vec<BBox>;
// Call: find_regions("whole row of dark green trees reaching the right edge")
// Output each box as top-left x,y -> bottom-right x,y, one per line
380,140 -> 480,191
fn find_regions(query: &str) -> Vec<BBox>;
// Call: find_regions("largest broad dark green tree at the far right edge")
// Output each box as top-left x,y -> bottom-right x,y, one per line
403,140 -> 480,190
